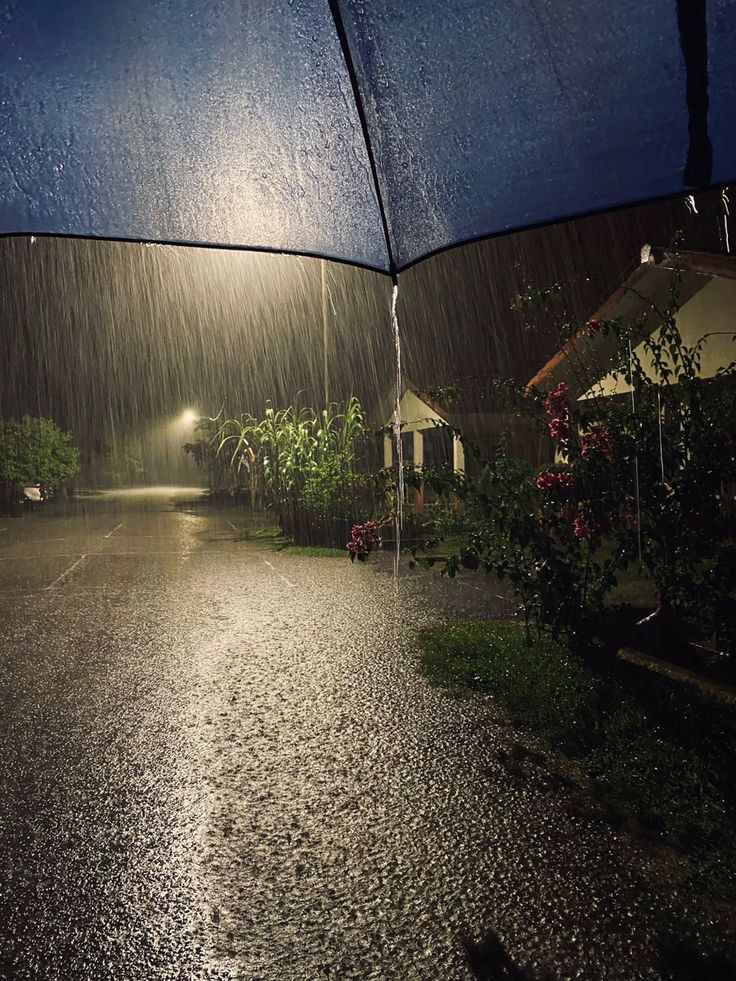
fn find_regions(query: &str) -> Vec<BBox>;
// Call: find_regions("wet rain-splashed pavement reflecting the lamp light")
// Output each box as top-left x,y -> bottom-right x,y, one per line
0,493 -> 720,981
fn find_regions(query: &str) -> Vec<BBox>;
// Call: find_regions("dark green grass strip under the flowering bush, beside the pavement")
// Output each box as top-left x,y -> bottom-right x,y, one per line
419,621 -> 736,900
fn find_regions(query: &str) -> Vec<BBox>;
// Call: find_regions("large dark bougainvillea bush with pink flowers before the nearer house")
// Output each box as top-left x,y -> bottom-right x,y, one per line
402,262 -> 736,649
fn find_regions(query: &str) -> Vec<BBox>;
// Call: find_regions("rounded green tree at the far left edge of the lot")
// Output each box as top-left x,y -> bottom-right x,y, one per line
0,415 -> 79,490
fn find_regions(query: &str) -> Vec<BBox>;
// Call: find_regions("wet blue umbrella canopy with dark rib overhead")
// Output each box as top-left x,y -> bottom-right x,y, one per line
0,0 -> 736,273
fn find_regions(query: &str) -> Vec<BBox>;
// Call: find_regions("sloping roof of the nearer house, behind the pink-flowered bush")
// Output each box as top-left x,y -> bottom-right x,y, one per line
527,245 -> 736,397
